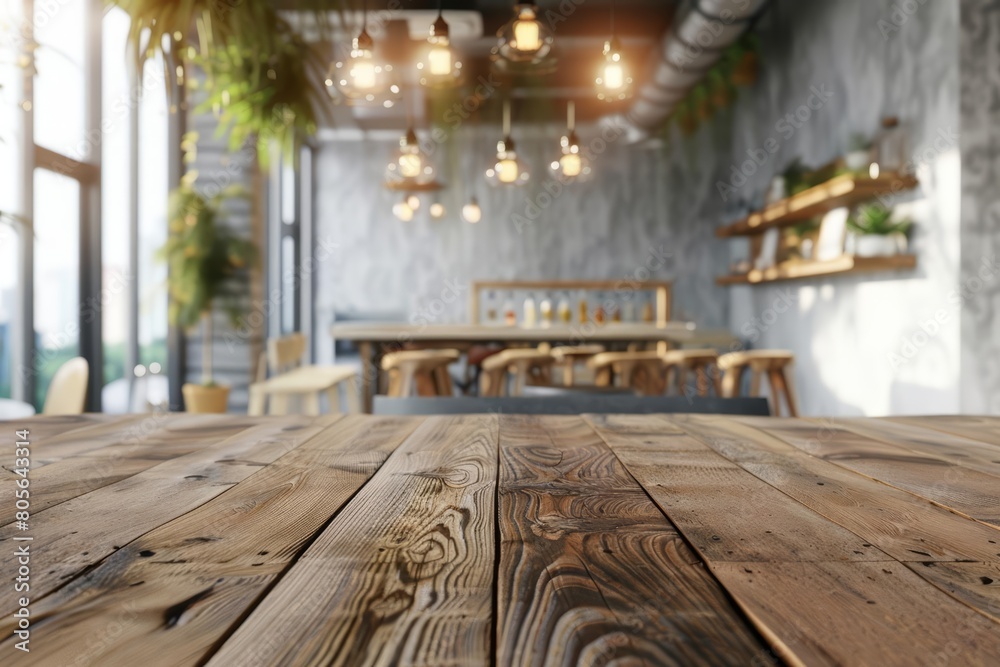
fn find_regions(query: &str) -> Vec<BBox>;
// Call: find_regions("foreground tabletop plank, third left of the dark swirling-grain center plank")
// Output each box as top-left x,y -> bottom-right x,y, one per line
0,417 -> 336,614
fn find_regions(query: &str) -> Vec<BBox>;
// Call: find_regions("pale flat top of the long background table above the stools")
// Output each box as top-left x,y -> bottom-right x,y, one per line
330,322 -> 736,346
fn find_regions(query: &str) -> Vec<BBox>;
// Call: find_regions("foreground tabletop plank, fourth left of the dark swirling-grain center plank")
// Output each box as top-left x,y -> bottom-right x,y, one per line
0,414 -> 270,525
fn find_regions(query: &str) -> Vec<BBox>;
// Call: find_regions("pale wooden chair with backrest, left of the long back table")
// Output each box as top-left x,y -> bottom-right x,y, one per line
247,333 -> 361,416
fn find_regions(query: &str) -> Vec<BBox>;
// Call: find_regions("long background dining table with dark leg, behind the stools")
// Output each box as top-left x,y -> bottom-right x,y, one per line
330,321 -> 738,412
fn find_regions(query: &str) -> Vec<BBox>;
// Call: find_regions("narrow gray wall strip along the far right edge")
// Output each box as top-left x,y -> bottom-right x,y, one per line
958,0 -> 1000,413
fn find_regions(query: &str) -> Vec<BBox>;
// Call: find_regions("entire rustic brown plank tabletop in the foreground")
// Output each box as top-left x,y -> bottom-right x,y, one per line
0,415 -> 1000,667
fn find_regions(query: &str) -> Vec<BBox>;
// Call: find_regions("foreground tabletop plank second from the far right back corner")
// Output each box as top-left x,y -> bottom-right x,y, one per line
837,419 -> 1000,477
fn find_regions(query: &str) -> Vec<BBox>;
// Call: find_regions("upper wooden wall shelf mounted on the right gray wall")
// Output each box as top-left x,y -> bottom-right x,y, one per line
715,173 -> 918,238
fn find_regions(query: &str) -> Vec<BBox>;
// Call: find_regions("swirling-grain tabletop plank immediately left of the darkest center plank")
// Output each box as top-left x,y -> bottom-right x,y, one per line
208,415 -> 498,667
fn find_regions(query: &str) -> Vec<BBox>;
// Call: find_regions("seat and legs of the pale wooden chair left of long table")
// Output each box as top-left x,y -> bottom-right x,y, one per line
247,366 -> 361,416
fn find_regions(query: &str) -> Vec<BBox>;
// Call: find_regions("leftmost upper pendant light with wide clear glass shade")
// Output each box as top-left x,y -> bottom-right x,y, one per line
326,0 -> 399,106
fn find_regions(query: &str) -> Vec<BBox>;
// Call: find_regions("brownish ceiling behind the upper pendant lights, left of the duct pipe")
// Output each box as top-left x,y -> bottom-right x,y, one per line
280,0 -> 679,131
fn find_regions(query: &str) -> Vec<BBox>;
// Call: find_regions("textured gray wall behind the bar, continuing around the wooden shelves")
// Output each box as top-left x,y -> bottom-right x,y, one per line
315,0 -> 968,415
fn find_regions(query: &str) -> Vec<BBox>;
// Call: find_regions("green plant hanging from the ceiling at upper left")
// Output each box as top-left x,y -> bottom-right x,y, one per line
108,0 -> 326,163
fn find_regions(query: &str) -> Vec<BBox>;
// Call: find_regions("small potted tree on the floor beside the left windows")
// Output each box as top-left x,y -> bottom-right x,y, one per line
159,179 -> 257,412
